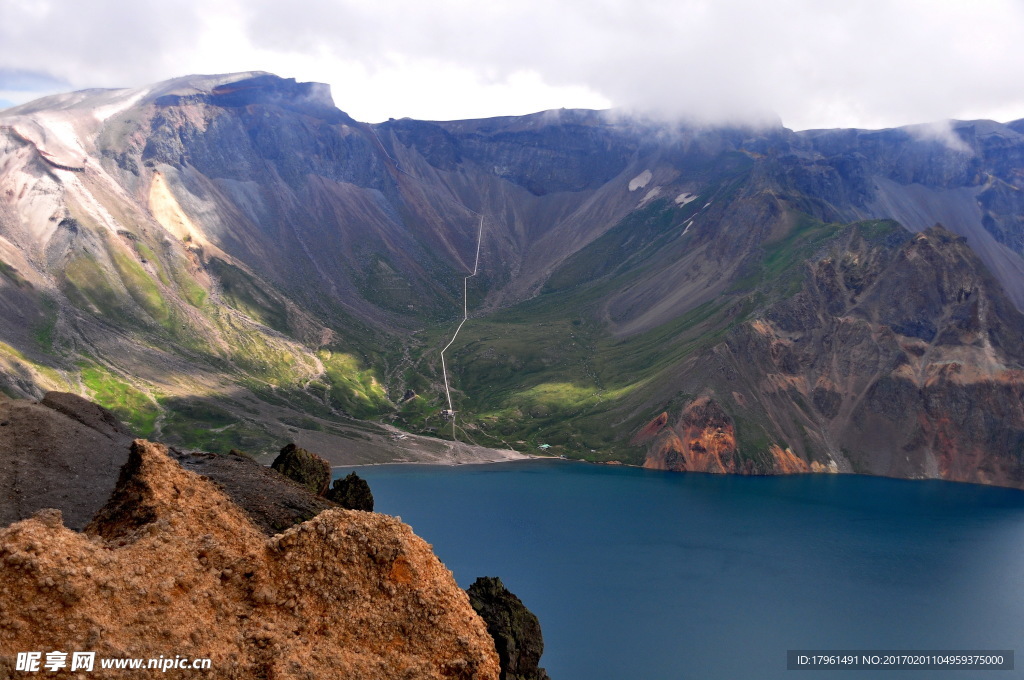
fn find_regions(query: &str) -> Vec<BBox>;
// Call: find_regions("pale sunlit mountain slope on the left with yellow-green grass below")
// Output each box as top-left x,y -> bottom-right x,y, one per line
0,76 -> 390,451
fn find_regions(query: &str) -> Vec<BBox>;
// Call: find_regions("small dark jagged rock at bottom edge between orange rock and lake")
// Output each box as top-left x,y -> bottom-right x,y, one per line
467,577 -> 550,680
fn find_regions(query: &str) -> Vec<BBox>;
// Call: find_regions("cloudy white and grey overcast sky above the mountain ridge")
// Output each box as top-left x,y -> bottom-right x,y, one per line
0,0 -> 1024,129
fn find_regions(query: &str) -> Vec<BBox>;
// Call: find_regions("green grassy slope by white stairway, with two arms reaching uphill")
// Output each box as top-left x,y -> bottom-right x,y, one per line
399,209 -> 901,462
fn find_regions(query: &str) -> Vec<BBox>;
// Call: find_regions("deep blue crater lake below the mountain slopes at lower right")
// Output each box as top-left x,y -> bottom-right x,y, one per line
335,461 -> 1024,680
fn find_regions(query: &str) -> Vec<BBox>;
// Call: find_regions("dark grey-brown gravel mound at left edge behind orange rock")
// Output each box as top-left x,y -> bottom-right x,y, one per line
0,392 -> 132,529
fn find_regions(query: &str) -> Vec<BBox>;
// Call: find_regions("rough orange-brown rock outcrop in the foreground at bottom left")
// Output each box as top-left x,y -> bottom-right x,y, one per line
0,440 -> 499,680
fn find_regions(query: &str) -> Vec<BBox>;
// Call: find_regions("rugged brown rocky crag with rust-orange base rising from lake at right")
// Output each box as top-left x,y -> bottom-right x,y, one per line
635,225 -> 1024,486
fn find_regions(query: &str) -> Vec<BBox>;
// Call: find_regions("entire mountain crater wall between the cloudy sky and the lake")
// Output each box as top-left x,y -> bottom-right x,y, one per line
0,73 -> 1024,486
